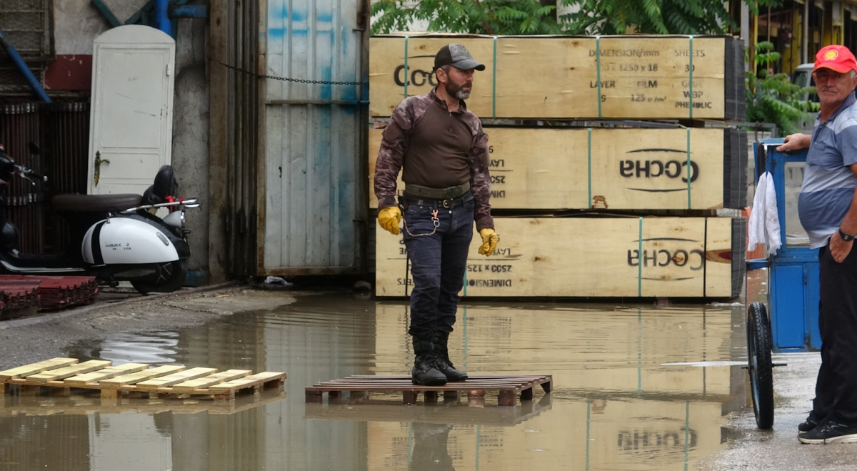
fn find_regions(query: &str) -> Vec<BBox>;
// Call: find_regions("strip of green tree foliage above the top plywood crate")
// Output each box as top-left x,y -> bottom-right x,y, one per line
371,0 -> 783,35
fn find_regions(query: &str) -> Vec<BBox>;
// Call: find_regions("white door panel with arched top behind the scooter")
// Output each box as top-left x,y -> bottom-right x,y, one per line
88,25 -> 175,194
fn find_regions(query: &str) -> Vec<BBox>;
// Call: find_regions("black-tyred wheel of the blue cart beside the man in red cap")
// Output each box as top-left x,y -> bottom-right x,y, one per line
747,302 -> 774,430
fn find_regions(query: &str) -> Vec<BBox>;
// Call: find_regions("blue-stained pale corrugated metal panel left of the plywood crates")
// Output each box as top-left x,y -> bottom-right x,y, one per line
258,0 -> 369,275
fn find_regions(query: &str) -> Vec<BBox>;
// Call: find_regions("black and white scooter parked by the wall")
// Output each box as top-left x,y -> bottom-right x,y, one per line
0,144 -> 199,294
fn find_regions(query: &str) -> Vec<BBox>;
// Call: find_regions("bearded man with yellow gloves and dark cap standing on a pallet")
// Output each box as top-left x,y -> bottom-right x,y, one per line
375,44 -> 499,386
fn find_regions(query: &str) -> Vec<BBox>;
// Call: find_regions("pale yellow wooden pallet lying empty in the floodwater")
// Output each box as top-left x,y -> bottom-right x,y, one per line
0,358 -> 286,400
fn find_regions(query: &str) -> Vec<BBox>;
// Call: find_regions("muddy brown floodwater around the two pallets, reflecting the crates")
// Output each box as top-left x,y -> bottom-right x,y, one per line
0,295 -> 747,471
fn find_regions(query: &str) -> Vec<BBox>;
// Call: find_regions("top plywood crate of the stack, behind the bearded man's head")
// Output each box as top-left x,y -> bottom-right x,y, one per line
369,35 -> 746,121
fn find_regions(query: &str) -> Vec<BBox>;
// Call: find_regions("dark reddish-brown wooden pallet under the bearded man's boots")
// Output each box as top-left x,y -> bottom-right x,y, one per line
306,375 -> 552,407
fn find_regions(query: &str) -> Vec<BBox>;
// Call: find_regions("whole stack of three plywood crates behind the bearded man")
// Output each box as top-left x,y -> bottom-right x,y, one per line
369,35 -> 747,298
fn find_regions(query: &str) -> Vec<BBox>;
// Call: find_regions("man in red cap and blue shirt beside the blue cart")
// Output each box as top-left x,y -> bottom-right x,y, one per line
777,46 -> 857,444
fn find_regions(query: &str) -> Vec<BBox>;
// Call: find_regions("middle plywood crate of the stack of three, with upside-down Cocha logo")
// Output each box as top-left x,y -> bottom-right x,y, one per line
369,127 -> 747,210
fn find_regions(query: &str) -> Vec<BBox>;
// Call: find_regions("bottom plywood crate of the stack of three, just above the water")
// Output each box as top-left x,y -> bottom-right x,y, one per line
375,217 -> 745,298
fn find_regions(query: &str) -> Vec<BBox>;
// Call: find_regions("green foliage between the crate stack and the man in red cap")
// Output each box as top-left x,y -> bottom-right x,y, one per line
745,42 -> 819,138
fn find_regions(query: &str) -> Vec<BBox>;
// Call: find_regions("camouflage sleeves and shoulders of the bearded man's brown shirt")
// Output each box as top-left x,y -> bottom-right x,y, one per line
375,90 -> 494,230
